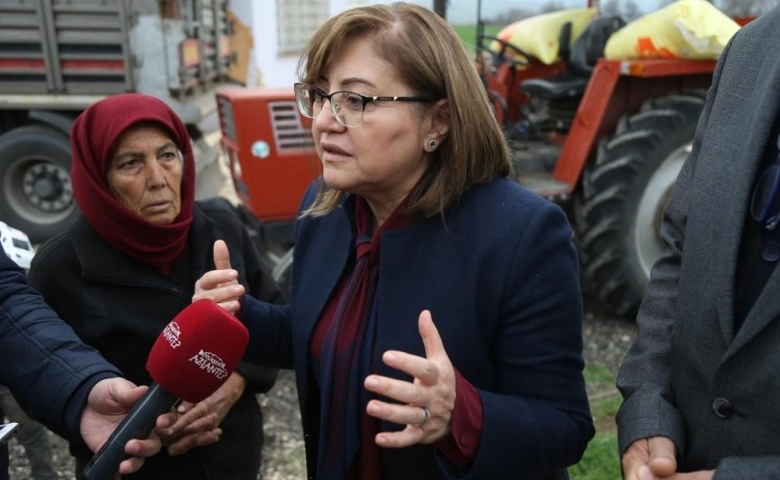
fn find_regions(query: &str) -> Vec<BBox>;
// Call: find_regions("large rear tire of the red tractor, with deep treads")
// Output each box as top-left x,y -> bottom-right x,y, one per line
573,91 -> 706,319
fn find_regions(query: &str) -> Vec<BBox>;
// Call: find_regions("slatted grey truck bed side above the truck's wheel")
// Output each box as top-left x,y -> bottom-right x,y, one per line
0,0 -> 230,99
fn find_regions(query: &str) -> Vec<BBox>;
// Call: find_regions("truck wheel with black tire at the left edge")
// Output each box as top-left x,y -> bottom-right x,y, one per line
0,125 -> 78,244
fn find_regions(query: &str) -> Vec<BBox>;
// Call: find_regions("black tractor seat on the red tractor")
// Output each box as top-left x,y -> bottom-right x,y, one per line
520,16 -> 626,100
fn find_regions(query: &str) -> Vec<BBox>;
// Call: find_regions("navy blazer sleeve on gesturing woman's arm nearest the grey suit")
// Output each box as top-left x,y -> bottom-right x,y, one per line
448,204 -> 594,480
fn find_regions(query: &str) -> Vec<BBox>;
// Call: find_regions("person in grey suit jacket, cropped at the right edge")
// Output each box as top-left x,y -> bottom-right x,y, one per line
616,6 -> 780,480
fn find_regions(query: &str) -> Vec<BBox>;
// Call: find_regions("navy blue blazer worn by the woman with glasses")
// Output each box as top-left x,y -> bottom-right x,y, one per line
242,178 -> 594,480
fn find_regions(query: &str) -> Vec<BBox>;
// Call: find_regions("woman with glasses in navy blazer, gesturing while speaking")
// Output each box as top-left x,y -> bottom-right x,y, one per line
195,4 -> 594,480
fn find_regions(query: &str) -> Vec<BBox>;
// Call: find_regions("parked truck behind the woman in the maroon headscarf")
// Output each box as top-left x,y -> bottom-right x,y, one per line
0,0 -> 233,244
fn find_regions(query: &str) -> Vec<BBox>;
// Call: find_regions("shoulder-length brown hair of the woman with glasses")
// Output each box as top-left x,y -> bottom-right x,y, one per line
298,2 -> 511,218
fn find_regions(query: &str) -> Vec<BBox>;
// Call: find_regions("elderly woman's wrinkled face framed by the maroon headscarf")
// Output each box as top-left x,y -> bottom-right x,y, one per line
108,125 -> 182,225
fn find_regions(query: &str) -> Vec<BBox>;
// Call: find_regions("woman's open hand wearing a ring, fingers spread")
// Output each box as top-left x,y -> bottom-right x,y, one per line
364,310 -> 455,448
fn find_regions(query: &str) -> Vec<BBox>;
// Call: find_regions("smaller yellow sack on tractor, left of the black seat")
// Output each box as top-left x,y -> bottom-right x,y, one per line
490,8 -> 596,65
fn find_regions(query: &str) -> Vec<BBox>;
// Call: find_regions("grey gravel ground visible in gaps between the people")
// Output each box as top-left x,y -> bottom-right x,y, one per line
10,314 -> 636,480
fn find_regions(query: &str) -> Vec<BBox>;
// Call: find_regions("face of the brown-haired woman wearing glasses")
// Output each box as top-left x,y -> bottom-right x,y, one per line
312,38 -> 429,208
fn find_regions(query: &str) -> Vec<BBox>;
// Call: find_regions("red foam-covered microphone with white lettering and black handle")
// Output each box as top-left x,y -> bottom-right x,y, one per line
84,299 -> 249,480
